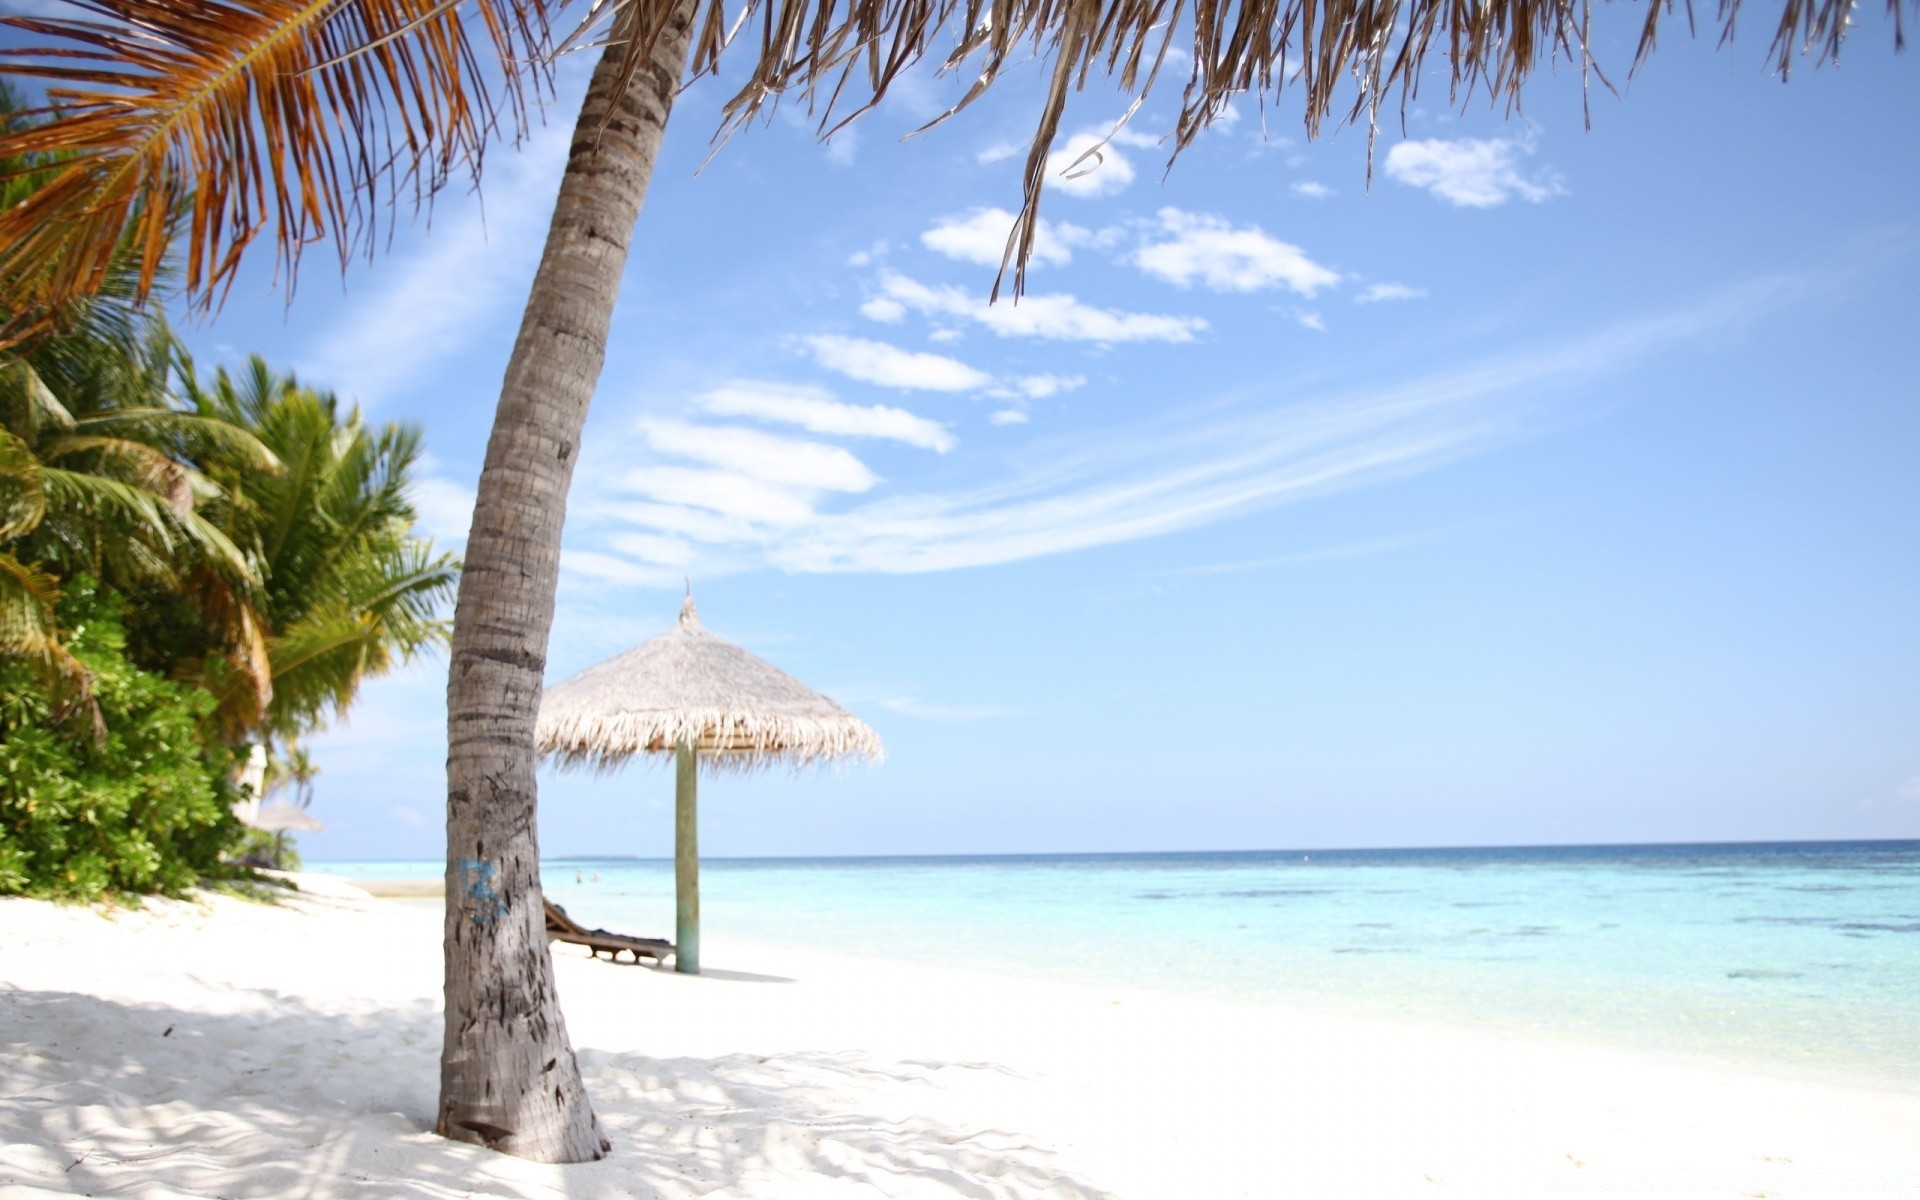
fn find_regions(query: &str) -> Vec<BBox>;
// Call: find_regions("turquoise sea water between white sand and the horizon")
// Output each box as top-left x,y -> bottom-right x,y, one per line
311,841 -> 1920,1091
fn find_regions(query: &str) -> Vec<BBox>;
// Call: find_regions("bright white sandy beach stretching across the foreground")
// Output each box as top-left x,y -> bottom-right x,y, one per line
0,885 -> 1920,1200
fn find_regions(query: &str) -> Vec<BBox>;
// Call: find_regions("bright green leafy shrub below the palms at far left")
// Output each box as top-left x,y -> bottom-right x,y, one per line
0,578 -> 244,899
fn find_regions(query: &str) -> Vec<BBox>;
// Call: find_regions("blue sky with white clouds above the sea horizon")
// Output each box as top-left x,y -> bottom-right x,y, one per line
139,10 -> 1920,858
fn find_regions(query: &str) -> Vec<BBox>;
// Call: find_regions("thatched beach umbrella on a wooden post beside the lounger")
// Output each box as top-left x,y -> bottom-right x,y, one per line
536,589 -> 881,975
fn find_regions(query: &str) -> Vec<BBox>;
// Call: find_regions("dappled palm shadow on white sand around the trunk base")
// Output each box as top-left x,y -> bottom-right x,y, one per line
0,989 -> 1110,1200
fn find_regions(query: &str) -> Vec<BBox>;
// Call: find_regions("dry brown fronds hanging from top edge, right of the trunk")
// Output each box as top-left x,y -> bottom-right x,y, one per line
664,0 -> 1920,296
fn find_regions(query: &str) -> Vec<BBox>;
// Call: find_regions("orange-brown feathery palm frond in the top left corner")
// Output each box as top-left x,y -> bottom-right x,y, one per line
0,0 -> 547,340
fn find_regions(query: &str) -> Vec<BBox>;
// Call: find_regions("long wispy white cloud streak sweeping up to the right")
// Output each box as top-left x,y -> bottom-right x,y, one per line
560,270 -> 1807,578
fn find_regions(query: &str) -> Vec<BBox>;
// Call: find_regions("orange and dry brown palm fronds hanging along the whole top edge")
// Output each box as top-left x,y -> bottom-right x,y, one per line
0,0 -> 1896,328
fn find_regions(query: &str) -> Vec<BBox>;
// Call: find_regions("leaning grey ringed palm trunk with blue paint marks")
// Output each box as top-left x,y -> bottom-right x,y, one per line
436,0 -> 691,1162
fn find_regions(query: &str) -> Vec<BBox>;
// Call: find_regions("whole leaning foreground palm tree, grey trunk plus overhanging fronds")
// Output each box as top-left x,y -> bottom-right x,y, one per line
0,0 -> 1889,1162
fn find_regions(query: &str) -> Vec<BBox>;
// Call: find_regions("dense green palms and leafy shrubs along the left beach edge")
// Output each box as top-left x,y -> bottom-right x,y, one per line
0,84 -> 457,897
